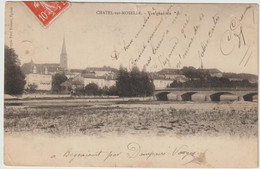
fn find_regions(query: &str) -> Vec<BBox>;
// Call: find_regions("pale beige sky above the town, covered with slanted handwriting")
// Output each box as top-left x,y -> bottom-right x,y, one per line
5,2 -> 258,74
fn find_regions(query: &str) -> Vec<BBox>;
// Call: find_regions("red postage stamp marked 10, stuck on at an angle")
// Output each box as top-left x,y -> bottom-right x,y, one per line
24,1 -> 69,26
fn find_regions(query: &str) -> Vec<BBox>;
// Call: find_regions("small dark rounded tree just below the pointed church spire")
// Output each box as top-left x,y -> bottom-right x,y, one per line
52,72 -> 68,93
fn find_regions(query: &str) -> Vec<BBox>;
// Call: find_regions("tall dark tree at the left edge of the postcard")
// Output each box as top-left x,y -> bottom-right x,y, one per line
4,46 -> 26,94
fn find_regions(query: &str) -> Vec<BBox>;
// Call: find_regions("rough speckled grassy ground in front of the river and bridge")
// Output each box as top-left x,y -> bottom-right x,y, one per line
4,101 -> 258,137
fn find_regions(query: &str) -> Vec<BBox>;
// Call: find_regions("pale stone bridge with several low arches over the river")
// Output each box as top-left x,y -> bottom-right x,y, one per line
154,88 -> 258,101
